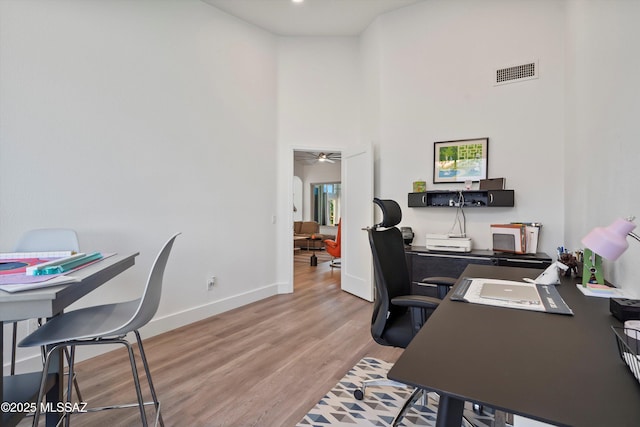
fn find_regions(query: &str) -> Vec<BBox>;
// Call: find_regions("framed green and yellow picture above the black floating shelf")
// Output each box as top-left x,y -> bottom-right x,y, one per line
433,138 -> 489,184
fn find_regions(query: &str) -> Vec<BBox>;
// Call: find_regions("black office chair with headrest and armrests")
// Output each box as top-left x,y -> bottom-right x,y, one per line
354,198 -> 440,426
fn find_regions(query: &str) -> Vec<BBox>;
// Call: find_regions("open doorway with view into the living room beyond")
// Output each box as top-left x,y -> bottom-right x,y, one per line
293,150 -> 342,291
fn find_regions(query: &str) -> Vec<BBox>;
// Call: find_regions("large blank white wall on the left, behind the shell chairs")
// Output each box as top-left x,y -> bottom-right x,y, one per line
0,0 -> 277,372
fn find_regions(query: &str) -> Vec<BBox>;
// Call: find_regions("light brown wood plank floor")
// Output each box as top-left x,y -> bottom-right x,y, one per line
32,250 -> 401,427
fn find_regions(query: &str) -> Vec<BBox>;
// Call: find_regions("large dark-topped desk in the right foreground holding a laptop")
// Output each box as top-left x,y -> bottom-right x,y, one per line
388,265 -> 640,427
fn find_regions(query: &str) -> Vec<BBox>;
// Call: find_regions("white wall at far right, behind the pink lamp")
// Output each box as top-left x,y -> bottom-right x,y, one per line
564,0 -> 640,298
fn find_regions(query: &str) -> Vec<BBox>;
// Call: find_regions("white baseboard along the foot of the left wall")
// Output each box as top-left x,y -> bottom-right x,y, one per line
3,284 -> 281,375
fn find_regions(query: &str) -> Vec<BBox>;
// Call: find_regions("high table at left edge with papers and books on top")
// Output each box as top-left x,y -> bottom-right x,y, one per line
0,253 -> 138,427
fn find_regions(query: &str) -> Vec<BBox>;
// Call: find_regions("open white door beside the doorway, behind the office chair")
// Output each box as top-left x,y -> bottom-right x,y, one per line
340,145 -> 373,301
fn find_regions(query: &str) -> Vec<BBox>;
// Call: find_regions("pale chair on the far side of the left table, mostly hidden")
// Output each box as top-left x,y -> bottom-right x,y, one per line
10,228 -> 80,396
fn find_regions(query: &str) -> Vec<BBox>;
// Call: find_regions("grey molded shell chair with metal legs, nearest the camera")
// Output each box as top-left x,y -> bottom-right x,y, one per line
19,233 -> 180,426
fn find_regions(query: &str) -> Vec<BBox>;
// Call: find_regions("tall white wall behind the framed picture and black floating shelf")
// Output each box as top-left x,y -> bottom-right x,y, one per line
362,0 -> 565,255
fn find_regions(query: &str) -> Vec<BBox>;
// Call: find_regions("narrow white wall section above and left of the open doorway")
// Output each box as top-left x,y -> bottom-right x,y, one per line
277,37 -> 361,292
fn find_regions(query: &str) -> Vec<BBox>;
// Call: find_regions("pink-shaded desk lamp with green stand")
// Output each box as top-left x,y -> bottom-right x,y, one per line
582,217 -> 640,286
